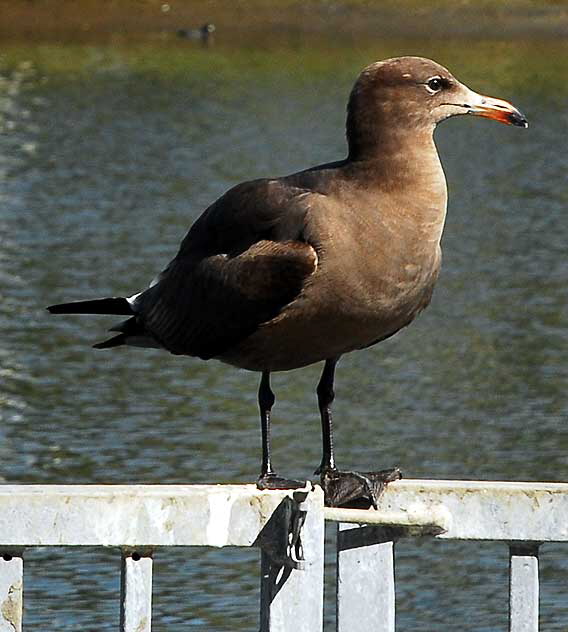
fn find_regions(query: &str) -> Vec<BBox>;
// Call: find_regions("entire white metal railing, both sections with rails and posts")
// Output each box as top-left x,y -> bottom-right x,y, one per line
0,480 -> 568,632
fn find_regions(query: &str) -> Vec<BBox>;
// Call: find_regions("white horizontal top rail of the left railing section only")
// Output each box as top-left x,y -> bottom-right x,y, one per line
0,485 -> 316,549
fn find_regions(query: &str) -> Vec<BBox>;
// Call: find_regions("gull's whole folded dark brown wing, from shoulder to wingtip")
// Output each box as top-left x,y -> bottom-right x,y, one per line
110,180 -> 318,359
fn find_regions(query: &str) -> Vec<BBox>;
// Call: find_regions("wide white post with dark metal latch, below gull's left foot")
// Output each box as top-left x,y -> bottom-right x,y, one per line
257,488 -> 324,632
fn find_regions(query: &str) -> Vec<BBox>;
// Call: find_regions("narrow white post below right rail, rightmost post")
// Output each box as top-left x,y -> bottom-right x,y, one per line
509,542 -> 539,632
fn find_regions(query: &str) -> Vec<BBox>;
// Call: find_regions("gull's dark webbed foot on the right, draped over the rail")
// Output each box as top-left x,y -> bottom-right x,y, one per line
320,467 -> 402,509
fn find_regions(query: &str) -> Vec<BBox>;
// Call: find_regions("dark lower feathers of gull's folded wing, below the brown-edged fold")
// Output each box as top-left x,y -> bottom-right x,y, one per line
139,240 -> 318,358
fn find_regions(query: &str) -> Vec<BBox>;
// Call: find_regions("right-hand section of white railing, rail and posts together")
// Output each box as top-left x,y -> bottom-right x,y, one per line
330,480 -> 568,632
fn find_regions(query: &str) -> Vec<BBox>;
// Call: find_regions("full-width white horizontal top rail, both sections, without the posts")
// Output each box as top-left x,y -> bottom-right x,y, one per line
0,479 -> 568,548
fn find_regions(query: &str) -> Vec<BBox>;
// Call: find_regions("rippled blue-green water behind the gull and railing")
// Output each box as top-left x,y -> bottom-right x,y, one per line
0,38 -> 568,632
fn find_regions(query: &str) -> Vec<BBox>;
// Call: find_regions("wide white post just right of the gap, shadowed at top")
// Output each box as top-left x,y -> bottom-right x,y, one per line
337,523 -> 396,632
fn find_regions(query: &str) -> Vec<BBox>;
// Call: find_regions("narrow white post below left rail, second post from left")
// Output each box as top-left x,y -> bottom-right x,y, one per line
120,551 -> 152,632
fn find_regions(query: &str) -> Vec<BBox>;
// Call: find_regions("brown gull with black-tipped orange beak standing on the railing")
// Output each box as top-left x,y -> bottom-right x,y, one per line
48,57 -> 528,506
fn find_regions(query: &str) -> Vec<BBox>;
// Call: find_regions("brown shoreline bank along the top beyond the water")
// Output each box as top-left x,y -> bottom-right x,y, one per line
0,0 -> 568,41
